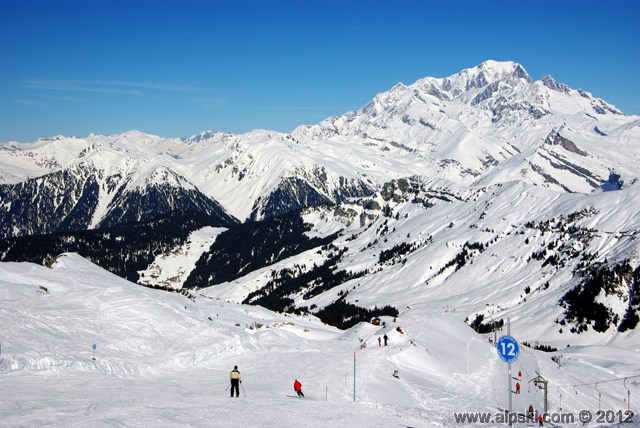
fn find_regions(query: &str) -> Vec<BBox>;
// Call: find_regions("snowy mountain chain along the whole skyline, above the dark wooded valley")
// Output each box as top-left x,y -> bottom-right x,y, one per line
0,61 -> 640,237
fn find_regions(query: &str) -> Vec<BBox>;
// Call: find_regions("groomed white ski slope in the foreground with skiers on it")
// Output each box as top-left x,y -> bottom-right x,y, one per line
0,254 -> 640,427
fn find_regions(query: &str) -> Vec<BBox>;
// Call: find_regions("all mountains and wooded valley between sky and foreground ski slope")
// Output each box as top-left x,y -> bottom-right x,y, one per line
0,61 -> 640,344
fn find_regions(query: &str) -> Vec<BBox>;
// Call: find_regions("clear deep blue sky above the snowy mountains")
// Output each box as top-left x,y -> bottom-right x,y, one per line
0,0 -> 640,141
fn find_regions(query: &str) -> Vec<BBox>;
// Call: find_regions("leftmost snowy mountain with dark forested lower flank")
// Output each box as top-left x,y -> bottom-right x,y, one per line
0,132 -> 237,236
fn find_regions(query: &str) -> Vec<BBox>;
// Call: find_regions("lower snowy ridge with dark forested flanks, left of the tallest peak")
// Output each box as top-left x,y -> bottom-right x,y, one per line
0,131 -> 373,237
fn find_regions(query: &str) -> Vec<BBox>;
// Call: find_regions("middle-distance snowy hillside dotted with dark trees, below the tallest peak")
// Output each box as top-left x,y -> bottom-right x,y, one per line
196,173 -> 640,348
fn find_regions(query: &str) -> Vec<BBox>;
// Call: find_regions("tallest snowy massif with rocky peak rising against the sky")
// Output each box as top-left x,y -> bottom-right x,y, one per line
292,61 -> 639,193
